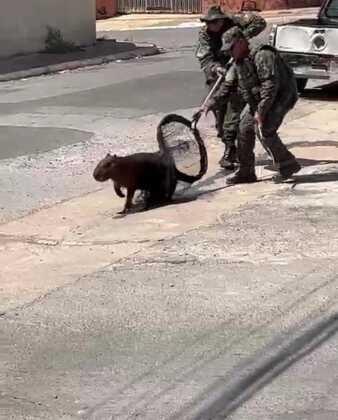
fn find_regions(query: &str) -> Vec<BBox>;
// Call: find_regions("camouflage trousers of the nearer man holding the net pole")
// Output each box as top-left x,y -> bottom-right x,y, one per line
238,101 -> 296,172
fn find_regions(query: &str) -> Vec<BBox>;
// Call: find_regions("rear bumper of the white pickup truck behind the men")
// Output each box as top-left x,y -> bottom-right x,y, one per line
281,52 -> 338,80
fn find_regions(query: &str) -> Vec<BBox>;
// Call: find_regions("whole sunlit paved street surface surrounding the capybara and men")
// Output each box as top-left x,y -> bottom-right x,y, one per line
0,22 -> 338,420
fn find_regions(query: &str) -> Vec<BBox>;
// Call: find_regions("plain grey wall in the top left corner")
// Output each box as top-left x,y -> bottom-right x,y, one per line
0,0 -> 96,56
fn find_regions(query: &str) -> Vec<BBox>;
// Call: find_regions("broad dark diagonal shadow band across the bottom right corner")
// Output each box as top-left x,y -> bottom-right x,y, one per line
171,314 -> 338,420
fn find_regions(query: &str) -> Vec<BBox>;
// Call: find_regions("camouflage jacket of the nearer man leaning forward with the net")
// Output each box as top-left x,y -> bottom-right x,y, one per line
211,45 -> 298,119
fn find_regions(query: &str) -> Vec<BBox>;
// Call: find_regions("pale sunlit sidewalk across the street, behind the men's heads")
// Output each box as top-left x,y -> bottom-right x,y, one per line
96,7 -> 319,32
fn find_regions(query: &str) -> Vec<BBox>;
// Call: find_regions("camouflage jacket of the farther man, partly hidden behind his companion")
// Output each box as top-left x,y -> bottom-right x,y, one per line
196,13 -> 266,83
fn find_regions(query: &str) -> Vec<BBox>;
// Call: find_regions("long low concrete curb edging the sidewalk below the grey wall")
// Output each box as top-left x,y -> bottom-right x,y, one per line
0,44 -> 161,82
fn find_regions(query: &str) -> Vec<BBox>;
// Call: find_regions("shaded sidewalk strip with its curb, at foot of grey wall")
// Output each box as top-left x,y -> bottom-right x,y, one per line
0,39 -> 159,82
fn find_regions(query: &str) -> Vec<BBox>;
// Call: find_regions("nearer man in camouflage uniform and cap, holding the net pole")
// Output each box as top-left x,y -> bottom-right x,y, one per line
204,28 -> 300,184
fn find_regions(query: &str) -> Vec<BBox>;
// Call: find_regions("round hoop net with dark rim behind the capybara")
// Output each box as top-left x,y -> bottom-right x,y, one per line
157,114 -> 208,182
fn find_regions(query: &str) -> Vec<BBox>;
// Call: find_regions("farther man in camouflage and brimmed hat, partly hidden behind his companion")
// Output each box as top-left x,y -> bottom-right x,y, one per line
196,6 -> 266,169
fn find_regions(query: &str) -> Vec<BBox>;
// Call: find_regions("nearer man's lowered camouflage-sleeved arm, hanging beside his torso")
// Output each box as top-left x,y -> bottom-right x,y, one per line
255,50 -> 279,120
